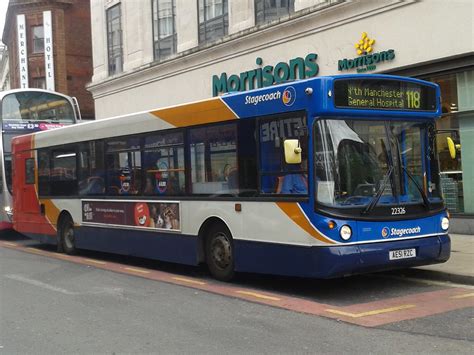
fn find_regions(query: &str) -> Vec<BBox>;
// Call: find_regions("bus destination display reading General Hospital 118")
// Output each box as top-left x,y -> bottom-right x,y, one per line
334,79 -> 436,111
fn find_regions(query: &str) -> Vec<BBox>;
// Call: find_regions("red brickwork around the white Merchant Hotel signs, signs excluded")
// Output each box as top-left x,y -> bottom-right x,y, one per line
2,0 -> 94,118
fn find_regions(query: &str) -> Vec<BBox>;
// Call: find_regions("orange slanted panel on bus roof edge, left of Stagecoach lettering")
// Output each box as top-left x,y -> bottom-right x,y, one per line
151,98 -> 237,127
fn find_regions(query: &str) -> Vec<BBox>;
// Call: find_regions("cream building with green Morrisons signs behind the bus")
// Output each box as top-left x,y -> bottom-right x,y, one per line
89,0 -> 474,234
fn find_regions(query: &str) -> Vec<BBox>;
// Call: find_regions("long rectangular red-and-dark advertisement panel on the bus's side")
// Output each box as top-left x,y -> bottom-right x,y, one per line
82,201 -> 180,231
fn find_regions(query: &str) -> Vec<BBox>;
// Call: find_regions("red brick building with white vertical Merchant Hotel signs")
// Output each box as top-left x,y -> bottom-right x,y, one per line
3,0 -> 94,118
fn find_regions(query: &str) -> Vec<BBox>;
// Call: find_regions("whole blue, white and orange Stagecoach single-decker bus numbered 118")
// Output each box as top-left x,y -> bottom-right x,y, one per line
13,75 -> 450,280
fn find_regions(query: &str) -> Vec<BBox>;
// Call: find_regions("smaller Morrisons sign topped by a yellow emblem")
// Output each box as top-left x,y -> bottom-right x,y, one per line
338,32 -> 395,73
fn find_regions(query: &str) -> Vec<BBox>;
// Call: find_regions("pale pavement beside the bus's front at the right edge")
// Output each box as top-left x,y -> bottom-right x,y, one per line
412,234 -> 474,285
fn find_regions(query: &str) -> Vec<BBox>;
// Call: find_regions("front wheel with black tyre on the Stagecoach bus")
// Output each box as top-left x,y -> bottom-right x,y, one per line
206,224 -> 234,281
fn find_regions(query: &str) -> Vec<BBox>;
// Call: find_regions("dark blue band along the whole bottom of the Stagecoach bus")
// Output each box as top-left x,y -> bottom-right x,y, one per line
23,227 -> 451,278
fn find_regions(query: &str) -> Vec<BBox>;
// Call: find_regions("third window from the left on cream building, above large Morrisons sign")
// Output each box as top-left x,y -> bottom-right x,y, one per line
197,0 -> 229,44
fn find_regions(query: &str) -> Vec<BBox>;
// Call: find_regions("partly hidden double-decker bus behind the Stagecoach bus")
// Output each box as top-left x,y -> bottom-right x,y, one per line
0,89 -> 80,230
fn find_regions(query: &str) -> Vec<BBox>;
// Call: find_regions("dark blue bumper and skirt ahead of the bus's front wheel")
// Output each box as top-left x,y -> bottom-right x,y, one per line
235,234 -> 451,279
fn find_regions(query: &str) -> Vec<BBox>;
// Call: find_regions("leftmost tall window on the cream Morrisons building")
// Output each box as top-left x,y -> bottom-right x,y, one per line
105,3 -> 123,75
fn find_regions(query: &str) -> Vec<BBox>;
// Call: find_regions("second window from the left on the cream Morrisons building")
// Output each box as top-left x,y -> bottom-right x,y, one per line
151,0 -> 177,61
